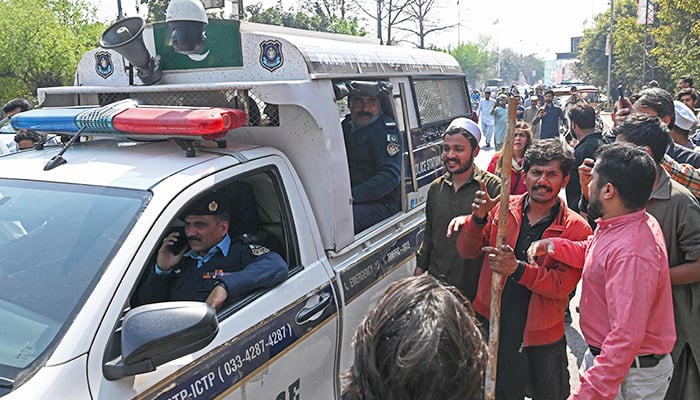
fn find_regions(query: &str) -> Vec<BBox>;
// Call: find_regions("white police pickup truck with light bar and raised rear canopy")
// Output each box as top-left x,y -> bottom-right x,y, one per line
0,2 -> 471,400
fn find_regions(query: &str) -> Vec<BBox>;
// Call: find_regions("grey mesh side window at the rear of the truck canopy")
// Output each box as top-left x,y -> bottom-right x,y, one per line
413,78 -> 469,126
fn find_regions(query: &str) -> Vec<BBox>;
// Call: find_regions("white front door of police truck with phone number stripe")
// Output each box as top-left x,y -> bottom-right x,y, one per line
88,156 -> 338,400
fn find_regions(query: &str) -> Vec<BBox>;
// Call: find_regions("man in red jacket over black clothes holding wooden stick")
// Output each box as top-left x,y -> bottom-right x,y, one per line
447,139 -> 591,400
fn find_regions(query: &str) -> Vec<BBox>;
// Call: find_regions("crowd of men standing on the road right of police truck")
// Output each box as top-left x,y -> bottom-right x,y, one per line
348,77 -> 700,400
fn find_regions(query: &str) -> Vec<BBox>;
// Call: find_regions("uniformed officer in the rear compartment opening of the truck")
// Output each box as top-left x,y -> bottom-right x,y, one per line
342,81 -> 403,232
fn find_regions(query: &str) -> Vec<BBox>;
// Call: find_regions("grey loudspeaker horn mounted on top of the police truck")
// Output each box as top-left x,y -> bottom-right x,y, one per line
100,17 -> 161,85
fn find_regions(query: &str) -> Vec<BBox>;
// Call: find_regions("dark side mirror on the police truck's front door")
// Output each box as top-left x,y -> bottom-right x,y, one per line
102,301 -> 219,380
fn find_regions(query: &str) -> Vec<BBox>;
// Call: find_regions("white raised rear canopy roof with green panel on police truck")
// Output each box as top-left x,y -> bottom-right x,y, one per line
72,19 -> 463,88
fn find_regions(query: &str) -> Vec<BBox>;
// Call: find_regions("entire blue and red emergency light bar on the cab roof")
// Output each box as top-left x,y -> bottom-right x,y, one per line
10,100 -> 248,140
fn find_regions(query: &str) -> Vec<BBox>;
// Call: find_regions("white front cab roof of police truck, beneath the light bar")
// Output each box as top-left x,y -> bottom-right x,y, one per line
0,139 -> 258,190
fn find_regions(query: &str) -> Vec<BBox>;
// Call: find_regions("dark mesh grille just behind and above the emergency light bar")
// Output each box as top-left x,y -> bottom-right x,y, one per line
98,90 -> 280,126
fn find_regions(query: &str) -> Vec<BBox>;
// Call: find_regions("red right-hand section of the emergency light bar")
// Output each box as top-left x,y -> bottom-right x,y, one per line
112,106 -> 248,139
